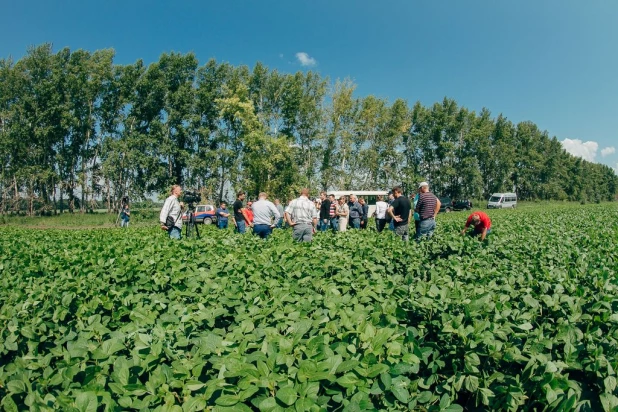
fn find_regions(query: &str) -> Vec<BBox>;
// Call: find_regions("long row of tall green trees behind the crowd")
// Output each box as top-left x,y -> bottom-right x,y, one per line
0,44 -> 618,213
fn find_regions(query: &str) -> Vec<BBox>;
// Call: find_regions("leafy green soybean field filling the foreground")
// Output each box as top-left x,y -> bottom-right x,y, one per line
0,203 -> 618,412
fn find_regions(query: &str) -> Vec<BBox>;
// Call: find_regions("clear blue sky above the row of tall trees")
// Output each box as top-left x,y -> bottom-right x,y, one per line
0,0 -> 618,168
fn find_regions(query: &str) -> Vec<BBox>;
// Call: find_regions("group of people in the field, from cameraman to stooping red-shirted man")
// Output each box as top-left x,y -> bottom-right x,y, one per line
159,182 -> 491,242
